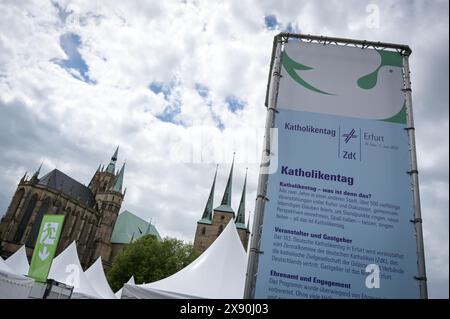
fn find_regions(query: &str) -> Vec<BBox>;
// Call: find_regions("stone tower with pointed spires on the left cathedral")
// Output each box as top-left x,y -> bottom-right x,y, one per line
89,147 -> 126,268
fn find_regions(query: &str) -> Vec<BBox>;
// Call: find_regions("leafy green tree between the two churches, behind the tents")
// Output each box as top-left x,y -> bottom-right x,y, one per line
108,235 -> 200,291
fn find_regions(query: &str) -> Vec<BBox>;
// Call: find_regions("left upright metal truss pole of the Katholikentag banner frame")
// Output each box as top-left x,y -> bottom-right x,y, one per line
244,35 -> 282,299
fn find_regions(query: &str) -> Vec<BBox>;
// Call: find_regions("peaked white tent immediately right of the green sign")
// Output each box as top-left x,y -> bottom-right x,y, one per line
48,241 -> 102,299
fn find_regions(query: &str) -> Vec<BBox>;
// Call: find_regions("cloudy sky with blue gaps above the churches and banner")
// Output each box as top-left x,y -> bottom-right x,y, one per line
0,0 -> 449,298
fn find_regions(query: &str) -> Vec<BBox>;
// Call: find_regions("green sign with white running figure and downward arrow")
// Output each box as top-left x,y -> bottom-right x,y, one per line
28,215 -> 64,282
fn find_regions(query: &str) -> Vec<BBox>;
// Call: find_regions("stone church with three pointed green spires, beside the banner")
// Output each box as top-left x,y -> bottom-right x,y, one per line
194,159 -> 250,252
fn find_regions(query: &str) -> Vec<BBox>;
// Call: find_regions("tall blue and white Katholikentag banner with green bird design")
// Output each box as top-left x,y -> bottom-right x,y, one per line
254,40 -> 420,298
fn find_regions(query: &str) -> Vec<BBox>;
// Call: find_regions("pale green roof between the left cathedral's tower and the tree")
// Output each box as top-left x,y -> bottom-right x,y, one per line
111,210 -> 161,244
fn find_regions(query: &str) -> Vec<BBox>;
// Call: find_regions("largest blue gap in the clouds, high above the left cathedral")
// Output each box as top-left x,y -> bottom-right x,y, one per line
52,33 -> 95,84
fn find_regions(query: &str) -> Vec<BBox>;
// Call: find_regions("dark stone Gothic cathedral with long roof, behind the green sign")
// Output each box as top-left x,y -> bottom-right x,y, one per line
0,147 -> 132,269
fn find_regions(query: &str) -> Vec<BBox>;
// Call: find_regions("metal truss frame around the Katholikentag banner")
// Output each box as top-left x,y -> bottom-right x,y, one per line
244,33 -> 428,299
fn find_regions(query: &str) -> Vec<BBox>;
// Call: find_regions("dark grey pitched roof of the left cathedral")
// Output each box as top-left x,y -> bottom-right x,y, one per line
38,169 -> 95,207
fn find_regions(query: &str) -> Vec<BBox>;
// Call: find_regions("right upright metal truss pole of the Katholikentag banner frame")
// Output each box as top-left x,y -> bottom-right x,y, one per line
403,56 -> 428,299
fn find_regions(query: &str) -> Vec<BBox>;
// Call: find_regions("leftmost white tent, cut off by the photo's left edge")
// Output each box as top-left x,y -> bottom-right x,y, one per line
0,257 -> 34,299
